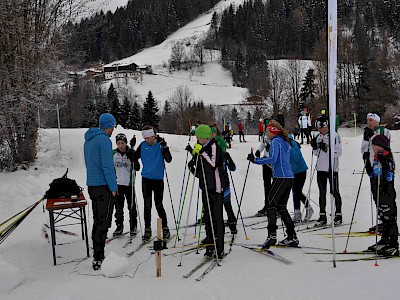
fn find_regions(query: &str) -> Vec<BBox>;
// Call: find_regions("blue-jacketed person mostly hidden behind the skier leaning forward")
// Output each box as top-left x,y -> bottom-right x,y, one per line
289,135 -> 314,223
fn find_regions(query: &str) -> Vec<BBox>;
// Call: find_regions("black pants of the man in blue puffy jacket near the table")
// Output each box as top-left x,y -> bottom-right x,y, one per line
88,185 -> 115,260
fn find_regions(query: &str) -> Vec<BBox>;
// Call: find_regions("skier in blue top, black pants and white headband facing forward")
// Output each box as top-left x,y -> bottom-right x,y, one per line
134,125 -> 172,241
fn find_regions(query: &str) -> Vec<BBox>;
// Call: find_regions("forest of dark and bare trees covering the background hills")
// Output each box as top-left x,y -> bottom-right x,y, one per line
0,0 -> 400,170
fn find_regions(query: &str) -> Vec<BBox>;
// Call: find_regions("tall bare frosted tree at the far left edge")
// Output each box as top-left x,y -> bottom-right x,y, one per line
0,0 -> 92,168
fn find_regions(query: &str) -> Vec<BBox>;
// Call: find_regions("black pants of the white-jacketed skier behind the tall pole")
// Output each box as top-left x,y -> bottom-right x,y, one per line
317,171 -> 342,215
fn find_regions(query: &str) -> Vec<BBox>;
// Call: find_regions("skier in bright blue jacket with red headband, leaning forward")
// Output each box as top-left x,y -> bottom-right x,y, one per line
247,120 -> 299,249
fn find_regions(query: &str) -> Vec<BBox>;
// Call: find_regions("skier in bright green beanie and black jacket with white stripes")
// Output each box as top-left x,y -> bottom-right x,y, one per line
186,125 -> 226,258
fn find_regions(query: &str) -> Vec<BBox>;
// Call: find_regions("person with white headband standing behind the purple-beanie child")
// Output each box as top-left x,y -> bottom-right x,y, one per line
361,112 -> 391,231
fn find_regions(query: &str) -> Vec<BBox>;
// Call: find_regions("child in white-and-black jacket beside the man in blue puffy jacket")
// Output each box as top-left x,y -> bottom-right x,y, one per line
113,133 -> 140,236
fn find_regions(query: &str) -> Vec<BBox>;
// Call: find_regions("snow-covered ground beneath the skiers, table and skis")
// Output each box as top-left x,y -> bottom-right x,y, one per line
0,127 -> 400,300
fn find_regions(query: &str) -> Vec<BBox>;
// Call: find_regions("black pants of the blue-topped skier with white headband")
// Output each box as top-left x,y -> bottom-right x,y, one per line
142,177 -> 168,228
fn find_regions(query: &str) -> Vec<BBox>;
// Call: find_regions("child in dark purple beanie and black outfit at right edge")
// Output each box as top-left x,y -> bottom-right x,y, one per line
368,135 -> 399,256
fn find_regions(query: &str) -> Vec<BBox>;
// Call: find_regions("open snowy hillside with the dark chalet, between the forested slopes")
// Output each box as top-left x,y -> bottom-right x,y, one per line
104,0 -> 247,107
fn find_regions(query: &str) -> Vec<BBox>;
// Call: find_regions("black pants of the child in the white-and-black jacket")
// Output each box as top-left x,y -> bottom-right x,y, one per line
114,185 -> 137,231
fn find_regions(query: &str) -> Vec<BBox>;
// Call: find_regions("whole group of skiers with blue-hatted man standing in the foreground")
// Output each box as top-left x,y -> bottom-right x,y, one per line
85,112 -> 399,270
